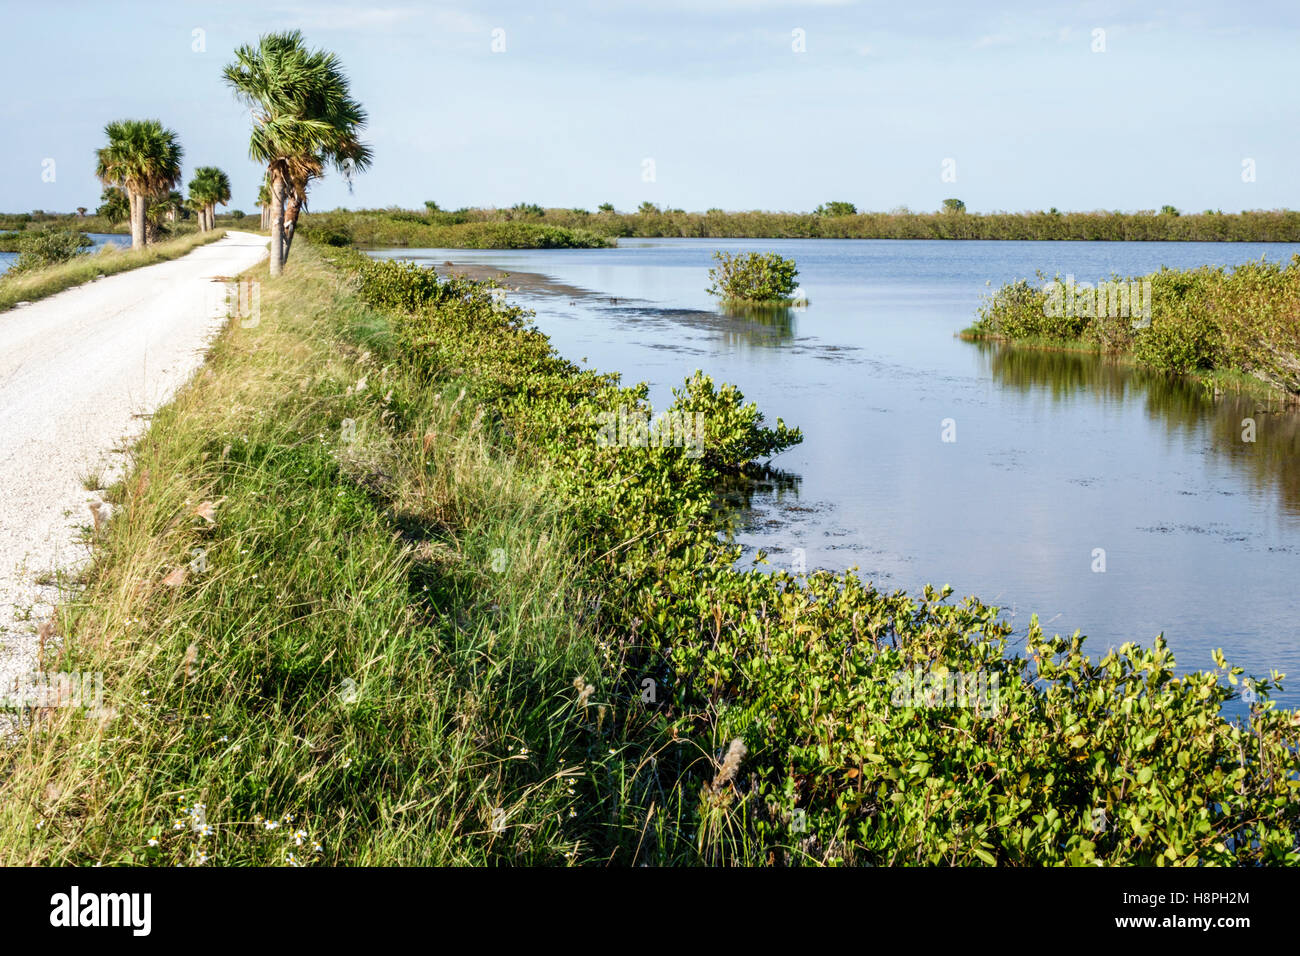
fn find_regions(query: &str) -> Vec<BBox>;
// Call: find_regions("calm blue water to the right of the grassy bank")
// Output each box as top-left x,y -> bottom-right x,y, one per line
377,239 -> 1300,706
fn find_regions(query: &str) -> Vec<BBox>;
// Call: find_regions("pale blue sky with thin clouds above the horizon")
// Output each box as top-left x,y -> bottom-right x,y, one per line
0,0 -> 1300,211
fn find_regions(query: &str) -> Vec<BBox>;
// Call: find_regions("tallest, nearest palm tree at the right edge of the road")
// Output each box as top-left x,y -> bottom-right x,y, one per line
224,30 -> 371,276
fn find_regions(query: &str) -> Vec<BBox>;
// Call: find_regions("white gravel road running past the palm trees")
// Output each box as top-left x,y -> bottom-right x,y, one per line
0,232 -> 267,697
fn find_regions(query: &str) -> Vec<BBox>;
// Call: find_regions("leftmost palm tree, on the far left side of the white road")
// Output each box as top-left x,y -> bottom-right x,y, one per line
95,120 -> 185,248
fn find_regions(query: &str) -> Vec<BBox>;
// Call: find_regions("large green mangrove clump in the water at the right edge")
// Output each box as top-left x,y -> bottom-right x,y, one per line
963,256 -> 1300,397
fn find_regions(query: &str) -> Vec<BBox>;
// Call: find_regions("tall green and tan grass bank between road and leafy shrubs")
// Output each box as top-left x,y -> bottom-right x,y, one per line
0,245 -> 624,865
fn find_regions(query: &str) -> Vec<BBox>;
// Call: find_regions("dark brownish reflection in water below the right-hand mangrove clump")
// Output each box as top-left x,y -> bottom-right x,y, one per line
974,342 -> 1300,518
